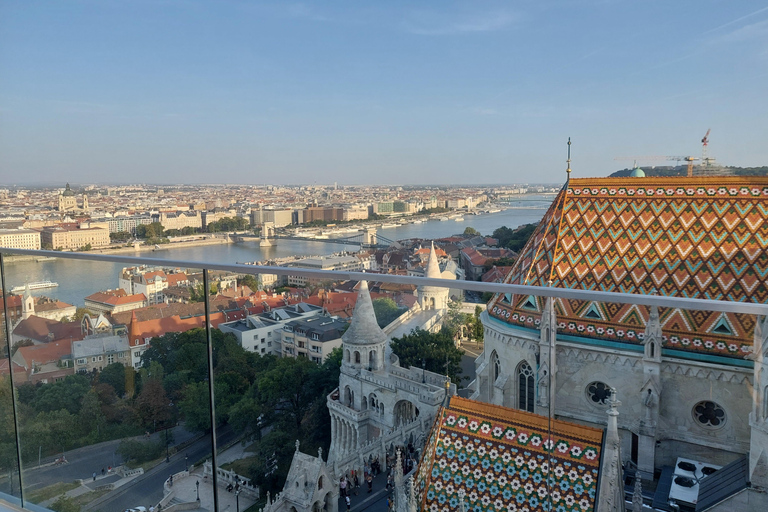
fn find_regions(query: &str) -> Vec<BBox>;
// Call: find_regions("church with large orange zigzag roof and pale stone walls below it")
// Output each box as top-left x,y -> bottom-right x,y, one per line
472,177 -> 768,492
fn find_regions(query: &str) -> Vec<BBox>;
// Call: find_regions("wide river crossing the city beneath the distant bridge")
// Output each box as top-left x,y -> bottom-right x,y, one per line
5,203 -> 551,306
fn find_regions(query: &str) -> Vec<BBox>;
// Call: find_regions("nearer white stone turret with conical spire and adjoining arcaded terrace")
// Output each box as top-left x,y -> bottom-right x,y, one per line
327,281 -> 455,472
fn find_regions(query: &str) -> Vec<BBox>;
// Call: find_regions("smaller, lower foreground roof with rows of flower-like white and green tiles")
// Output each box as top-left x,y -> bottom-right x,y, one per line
415,396 -> 603,512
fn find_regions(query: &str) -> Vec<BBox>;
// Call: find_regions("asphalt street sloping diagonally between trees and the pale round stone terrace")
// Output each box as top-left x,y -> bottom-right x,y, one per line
84,428 -> 238,512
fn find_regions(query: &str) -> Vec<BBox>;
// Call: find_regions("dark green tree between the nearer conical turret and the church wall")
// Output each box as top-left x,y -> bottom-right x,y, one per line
391,328 -> 464,385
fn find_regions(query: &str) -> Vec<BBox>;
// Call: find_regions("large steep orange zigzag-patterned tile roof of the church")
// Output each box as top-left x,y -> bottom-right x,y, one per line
489,176 -> 768,357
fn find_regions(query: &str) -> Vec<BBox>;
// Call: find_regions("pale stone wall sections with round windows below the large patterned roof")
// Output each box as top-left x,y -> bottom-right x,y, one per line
473,310 -> 752,467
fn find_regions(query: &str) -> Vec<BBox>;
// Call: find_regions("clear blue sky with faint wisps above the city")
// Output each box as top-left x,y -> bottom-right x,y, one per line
0,0 -> 768,186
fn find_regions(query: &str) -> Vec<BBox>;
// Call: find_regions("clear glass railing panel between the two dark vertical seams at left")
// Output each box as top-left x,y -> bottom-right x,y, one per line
0,254 -> 212,510
